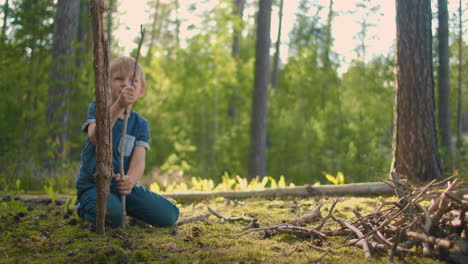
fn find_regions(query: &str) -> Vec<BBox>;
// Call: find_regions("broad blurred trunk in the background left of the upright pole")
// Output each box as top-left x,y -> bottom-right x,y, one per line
47,0 -> 80,165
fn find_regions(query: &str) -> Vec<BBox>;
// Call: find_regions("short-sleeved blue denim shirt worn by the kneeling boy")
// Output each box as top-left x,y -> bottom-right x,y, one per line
75,102 -> 150,197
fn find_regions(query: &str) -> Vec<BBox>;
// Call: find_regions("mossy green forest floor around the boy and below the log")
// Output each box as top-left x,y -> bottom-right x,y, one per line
0,194 -> 450,264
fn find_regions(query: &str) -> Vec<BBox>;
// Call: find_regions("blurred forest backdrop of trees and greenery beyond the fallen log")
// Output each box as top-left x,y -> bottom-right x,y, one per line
0,0 -> 468,192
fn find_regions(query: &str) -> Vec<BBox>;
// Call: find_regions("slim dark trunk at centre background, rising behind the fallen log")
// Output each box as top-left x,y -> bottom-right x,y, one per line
249,0 -> 272,179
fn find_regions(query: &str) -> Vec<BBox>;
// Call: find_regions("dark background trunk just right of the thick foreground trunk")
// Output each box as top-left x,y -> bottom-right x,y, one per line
437,0 -> 453,171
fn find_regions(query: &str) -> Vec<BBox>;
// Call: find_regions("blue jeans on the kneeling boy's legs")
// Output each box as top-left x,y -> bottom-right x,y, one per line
78,184 -> 179,227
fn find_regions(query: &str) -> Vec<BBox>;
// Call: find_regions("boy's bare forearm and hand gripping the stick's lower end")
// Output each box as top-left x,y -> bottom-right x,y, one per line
116,146 -> 146,195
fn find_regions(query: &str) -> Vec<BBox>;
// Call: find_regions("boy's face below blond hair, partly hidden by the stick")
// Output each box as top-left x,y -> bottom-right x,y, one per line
110,70 -> 145,102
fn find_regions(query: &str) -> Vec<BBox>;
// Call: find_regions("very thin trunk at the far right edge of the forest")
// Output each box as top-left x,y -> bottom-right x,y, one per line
457,0 -> 463,153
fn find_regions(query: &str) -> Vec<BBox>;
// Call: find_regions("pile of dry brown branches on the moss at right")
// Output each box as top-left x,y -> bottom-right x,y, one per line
236,179 -> 468,263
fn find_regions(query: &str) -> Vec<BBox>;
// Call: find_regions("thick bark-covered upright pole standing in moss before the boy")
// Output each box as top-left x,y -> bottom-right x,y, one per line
90,0 -> 113,234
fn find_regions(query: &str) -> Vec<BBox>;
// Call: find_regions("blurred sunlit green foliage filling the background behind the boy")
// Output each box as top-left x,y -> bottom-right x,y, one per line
0,0 -> 468,193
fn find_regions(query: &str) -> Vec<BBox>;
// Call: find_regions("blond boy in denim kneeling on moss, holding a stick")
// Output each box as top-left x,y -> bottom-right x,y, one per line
76,57 -> 179,227
